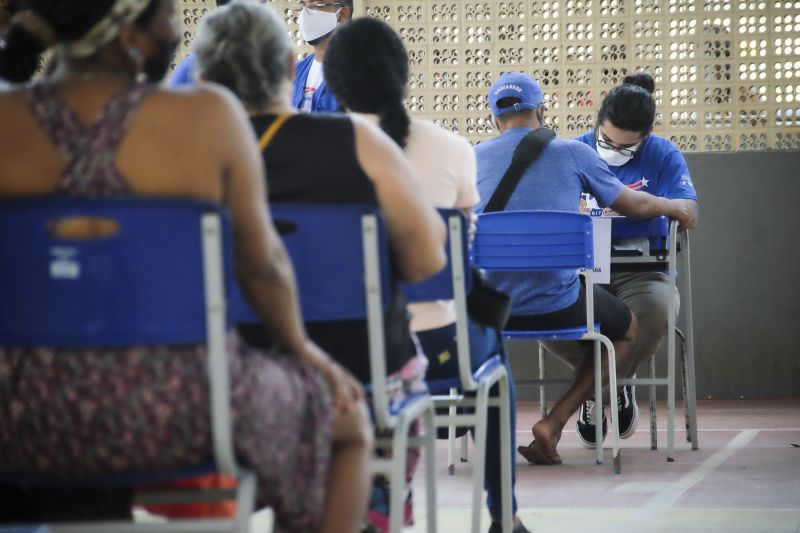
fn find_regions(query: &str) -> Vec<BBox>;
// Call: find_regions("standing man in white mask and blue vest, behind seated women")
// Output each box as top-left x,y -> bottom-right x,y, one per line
292,0 -> 353,112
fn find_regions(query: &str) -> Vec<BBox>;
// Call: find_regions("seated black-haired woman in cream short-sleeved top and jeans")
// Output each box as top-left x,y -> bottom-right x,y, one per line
324,17 -> 529,533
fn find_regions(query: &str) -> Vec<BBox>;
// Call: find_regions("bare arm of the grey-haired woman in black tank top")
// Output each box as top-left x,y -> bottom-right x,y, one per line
351,115 -> 446,281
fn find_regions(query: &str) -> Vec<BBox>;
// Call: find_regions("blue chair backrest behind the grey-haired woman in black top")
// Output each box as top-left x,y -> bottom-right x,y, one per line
238,203 -> 391,323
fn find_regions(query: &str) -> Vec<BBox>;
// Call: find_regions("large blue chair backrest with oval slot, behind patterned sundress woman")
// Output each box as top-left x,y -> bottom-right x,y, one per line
0,197 -> 235,347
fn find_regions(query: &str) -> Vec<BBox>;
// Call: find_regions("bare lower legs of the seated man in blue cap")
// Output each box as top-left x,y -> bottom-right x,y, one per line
520,314 -> 638,464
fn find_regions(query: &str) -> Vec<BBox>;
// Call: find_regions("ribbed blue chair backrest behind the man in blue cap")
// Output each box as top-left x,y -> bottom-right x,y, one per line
472,211 -> 594,272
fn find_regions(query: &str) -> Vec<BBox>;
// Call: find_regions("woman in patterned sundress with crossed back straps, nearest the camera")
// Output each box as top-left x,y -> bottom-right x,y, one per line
0,0 -> 371,533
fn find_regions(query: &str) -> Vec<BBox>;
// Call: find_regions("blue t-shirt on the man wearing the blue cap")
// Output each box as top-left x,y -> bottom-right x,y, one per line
475,128 -> 623,315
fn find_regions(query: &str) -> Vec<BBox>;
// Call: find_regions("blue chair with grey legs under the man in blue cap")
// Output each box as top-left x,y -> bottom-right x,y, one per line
472,211 -> 621,474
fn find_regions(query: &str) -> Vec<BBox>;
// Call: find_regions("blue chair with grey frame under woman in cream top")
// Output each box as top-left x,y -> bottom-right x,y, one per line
403,209 -> 513,533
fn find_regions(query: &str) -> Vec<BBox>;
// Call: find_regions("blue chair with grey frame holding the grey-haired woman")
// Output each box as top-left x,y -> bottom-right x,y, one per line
266,203 -> 436,533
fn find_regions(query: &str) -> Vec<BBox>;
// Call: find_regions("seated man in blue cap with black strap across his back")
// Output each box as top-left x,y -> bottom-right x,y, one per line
475,72 -> 689,464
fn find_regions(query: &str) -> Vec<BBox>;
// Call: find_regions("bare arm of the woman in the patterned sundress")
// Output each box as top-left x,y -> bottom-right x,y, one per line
206,90 -> 363,409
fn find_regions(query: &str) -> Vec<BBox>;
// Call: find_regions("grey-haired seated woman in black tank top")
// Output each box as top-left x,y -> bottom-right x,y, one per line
195,0 -> 445,526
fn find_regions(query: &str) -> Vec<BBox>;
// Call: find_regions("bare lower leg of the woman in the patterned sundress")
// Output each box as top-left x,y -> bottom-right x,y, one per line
320,402 -> 372,533
